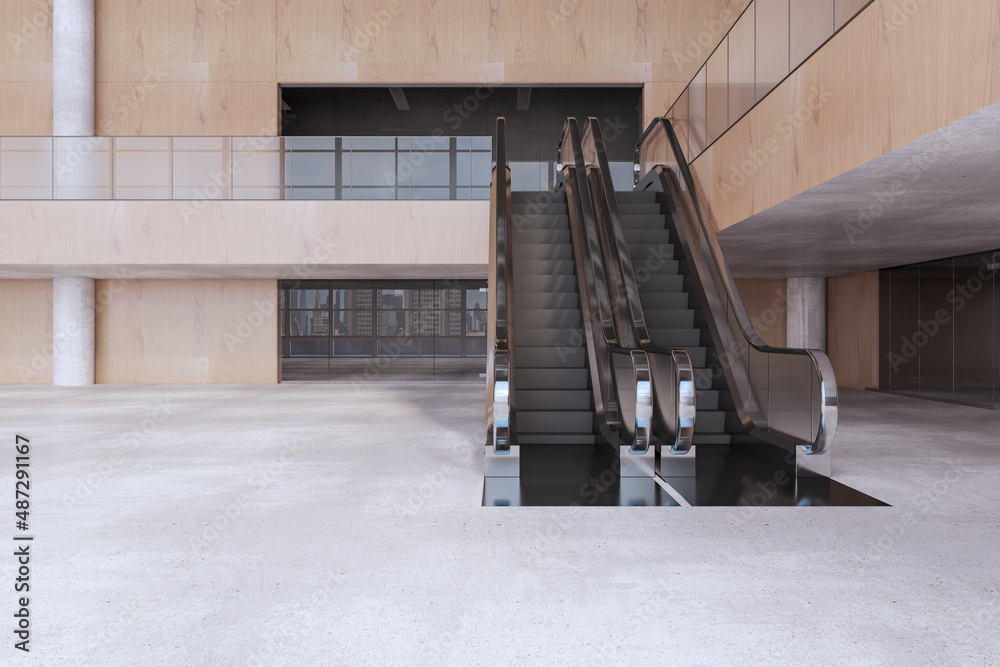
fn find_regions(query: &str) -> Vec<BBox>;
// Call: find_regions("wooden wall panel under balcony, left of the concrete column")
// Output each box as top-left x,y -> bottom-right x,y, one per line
0,280 -> 52,384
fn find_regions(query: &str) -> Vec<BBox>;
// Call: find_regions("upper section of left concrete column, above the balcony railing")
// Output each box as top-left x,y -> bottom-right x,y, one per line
52,0 -> 95,137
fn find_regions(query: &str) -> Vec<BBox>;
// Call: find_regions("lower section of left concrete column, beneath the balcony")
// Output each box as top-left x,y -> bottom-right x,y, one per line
52,278 -> 94,387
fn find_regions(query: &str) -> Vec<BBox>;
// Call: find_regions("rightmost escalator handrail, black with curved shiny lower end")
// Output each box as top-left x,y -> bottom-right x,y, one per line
633,117 -> 838,454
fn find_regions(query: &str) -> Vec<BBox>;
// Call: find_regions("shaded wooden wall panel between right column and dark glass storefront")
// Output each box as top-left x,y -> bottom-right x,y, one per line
826,271 -> 879,389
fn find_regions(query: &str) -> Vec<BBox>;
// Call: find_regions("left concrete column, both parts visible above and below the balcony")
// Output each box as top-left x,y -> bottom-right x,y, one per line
52,0 -> 95,387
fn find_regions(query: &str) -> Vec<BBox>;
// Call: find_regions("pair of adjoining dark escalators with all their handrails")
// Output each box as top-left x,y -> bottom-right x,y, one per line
484,118 -> 837,505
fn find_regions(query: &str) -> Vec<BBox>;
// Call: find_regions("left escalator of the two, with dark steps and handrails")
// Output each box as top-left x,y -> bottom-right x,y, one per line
486,119 -> 694,504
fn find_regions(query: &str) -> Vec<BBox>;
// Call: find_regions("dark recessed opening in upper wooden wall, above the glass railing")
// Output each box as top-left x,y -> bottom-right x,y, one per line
281,86 -> 642,162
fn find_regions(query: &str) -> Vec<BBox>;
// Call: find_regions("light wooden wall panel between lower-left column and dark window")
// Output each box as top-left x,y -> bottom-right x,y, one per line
96,280 -> 278,384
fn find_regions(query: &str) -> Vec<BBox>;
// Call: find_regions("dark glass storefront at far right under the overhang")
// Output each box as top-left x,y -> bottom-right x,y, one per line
879,251 -> 1000,408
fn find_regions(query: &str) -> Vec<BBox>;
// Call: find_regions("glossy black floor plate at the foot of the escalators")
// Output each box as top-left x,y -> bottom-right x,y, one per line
483,445 -> 885,507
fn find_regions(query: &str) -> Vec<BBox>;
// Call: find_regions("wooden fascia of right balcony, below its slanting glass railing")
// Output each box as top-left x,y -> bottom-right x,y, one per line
688,0 -> 1000,235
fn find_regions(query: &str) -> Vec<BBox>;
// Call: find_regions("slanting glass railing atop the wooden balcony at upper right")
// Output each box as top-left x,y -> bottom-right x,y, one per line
664,0 -> 872,162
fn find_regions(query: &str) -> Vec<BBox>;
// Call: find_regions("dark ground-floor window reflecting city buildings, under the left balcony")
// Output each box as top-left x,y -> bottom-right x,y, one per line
281,280 -> 487,382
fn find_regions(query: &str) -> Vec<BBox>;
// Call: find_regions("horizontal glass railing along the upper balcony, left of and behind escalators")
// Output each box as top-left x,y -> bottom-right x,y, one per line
0,137 -> 632,200
